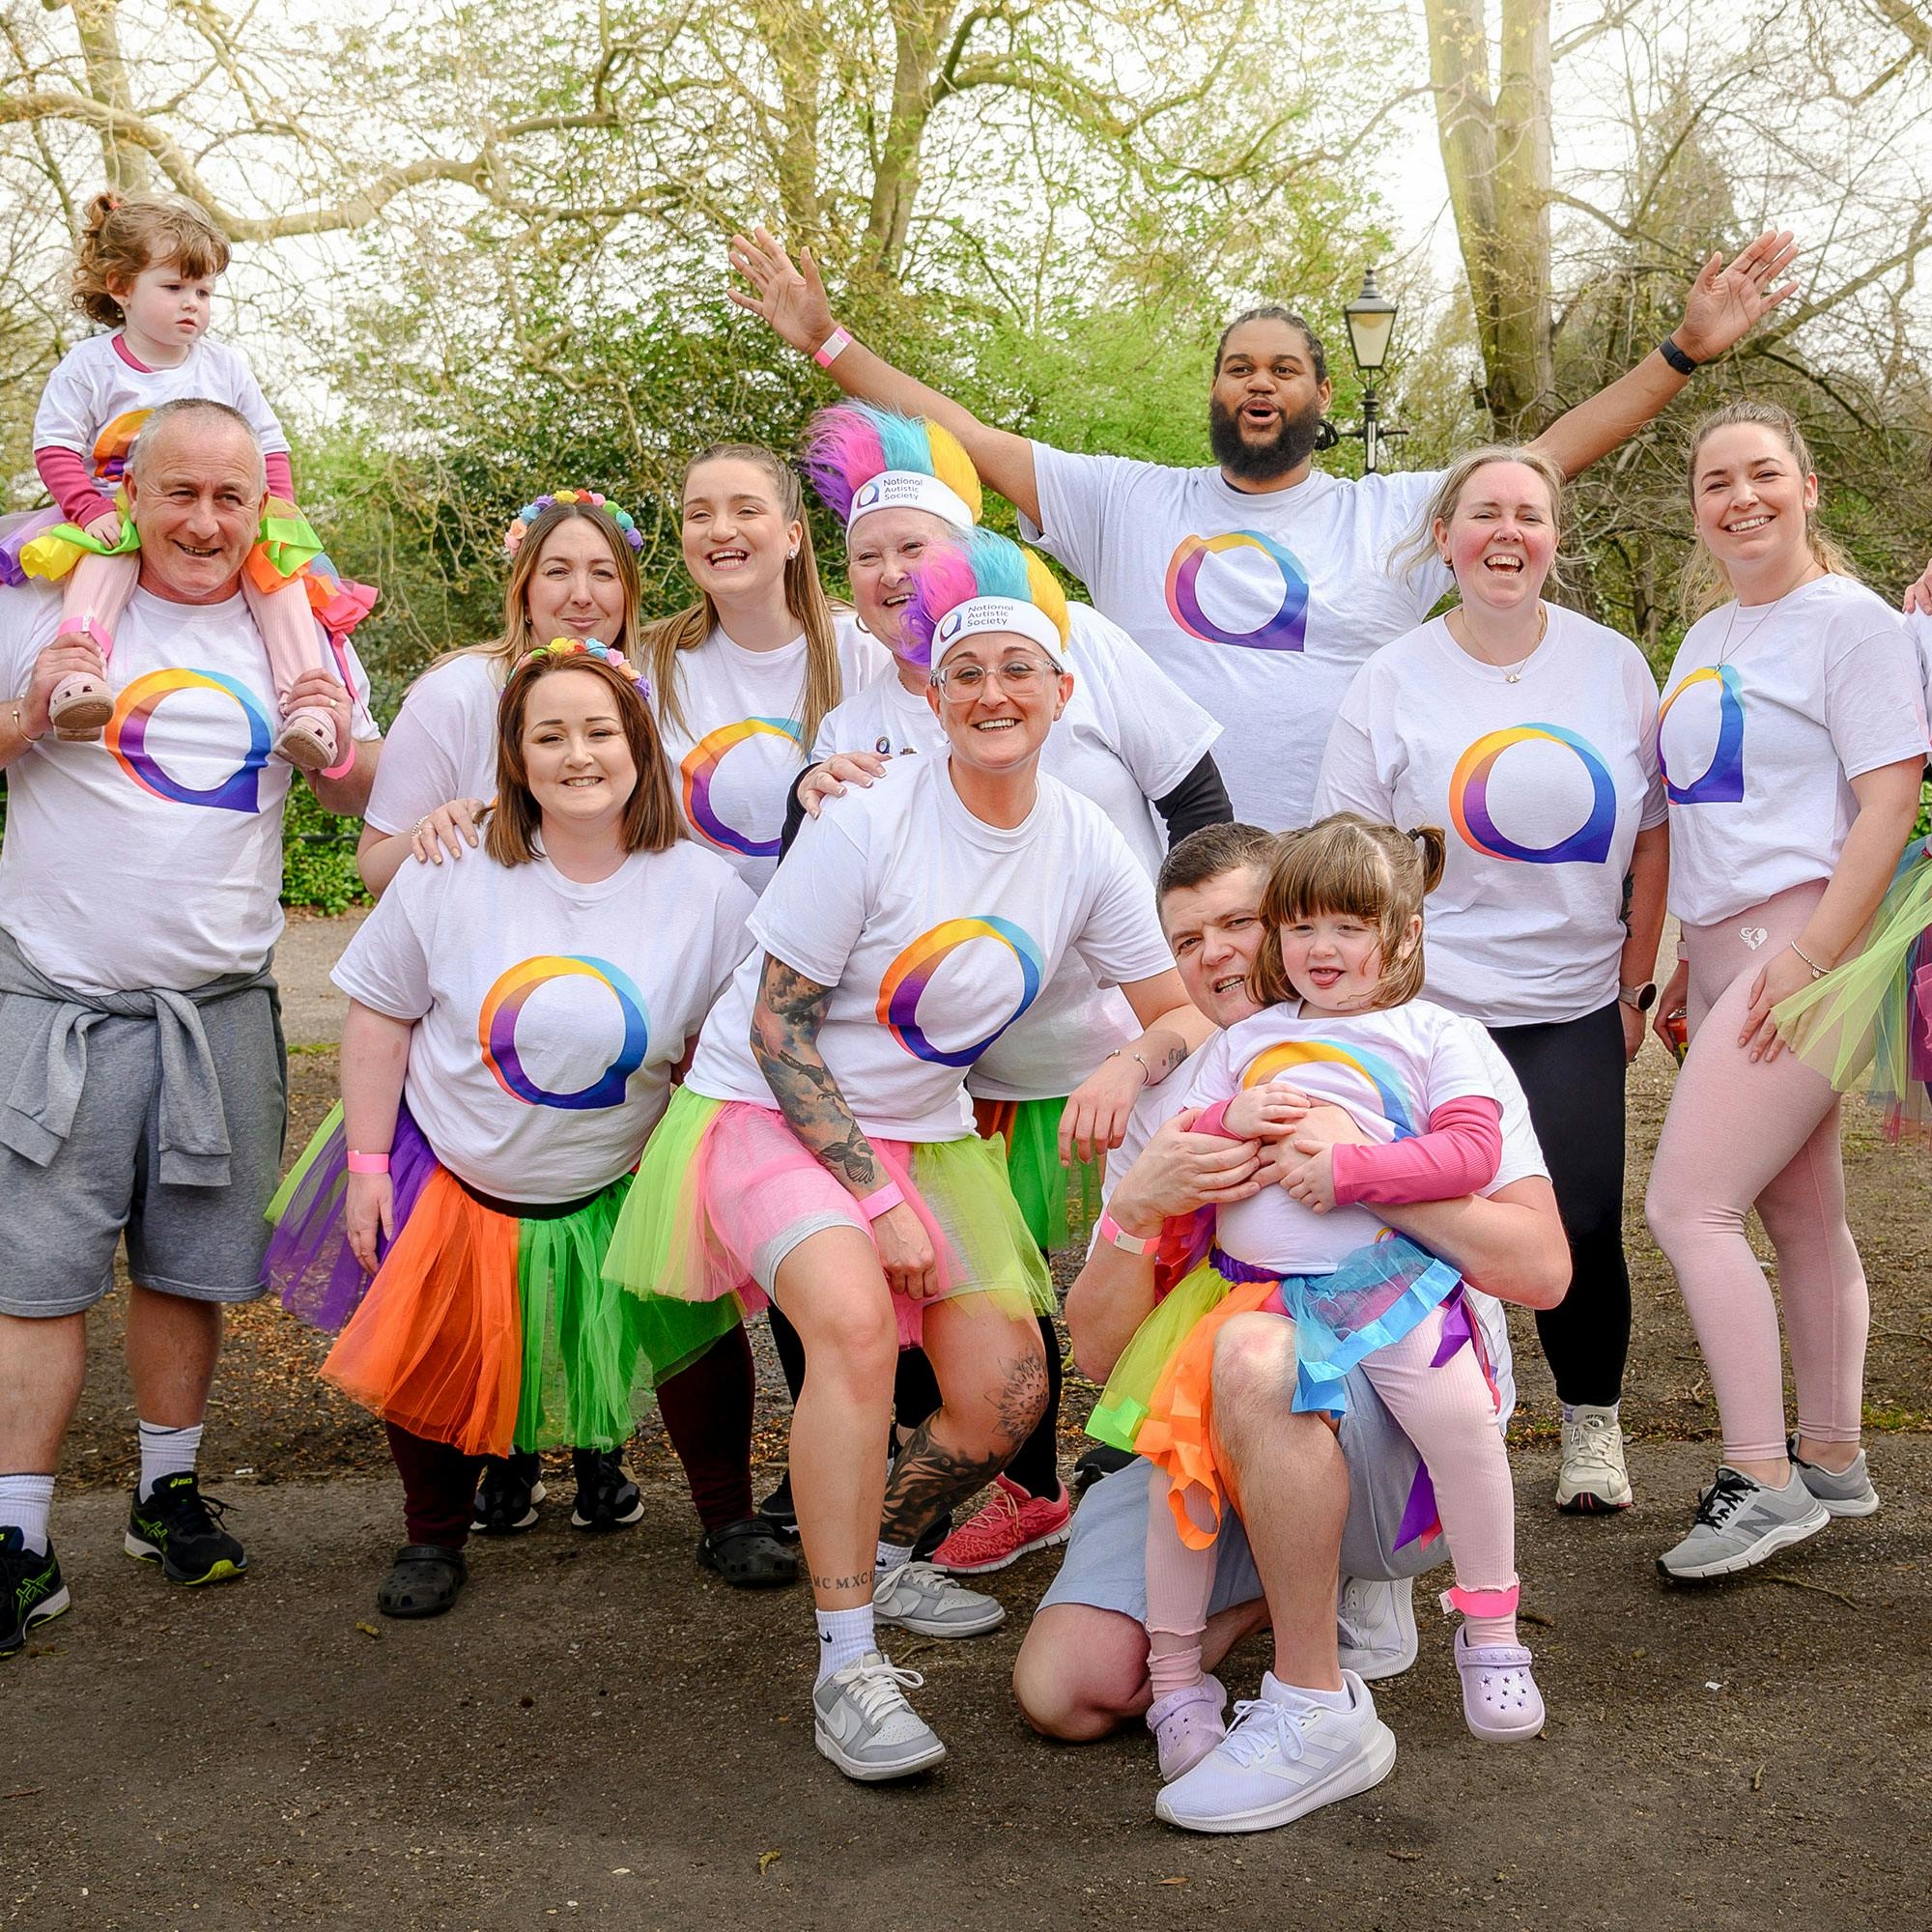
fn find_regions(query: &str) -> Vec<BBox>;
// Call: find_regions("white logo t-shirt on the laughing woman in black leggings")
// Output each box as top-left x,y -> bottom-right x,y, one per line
1314,605 -> 1665,1026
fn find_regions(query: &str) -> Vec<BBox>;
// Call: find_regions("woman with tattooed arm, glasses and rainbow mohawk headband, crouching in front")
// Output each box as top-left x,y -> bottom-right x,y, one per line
605,533 -> 1208,1781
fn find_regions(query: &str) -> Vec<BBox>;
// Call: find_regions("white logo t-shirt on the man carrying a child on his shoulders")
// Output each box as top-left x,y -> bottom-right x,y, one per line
0,587 -> 381,993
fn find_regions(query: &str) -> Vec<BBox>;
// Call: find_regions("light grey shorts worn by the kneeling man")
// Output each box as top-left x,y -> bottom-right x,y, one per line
1039,1370 -> 1449,1623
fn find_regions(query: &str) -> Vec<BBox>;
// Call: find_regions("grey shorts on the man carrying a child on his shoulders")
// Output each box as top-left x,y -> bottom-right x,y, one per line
0,987 -> 288,1316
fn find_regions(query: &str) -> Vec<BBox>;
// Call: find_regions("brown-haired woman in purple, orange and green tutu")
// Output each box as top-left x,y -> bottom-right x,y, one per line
269,639 -> 752,1617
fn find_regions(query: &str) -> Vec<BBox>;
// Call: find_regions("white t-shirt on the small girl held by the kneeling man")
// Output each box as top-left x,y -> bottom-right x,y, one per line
1186,999 -> 1501,1275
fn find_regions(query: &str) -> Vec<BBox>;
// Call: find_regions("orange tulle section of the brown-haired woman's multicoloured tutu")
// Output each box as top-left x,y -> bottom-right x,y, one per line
323,1167 -> 524,1455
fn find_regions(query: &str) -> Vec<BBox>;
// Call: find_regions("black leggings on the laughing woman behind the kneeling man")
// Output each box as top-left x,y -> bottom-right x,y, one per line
1490,1001 -> 1631,1408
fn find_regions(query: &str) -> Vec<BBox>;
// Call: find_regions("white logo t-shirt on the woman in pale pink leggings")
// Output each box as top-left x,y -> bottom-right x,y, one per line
1658,576 -> 1926,925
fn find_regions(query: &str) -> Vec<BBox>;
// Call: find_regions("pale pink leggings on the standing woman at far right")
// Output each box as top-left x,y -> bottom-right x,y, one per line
1644,879 -> 1870,1463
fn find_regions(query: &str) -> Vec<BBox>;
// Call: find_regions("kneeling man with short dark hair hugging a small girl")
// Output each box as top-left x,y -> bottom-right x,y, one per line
1012,825 -> 1569,1832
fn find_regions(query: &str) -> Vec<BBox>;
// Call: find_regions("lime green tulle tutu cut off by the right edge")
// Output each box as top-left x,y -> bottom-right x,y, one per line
1772,838 -> 1932,1140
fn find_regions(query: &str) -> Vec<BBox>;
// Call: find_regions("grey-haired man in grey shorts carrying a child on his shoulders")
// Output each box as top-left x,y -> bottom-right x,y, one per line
0,400 -> 379,1656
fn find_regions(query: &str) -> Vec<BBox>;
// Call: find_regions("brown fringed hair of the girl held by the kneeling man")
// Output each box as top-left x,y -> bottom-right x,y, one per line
1250,811 -> 1447,1007
